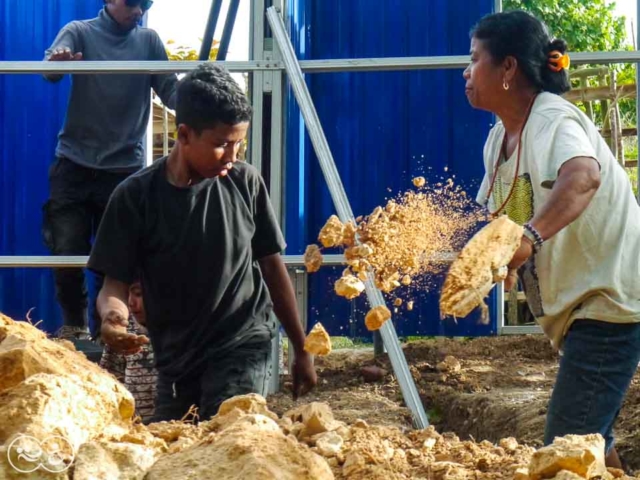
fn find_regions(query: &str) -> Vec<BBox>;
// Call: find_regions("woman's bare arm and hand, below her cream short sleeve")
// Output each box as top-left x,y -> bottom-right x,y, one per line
505,157 -> 600,290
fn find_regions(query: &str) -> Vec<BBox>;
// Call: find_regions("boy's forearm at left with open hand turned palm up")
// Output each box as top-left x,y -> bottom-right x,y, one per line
96,276 -> 149,354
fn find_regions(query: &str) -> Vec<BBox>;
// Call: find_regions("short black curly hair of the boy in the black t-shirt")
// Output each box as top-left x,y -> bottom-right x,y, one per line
176,63 -> 252,133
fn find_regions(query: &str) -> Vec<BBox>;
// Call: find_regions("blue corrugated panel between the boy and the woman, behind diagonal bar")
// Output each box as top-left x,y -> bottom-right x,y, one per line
285,0 -> 496,336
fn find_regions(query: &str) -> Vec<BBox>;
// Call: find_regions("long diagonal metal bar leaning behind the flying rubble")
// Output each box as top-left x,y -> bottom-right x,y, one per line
267,7 -> 429,428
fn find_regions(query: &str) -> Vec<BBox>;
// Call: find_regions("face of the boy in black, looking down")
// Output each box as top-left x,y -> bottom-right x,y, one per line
178,122 -> 249,178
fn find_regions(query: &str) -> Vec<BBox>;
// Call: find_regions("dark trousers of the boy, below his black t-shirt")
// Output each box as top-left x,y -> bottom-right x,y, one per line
151,340 -> 272,422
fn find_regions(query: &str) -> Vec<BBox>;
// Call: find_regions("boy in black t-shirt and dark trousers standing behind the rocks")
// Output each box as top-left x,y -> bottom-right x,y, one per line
89,64 -> 317,421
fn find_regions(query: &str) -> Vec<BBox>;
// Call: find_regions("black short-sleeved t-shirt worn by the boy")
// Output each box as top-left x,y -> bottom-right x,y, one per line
89,158 -> 285,379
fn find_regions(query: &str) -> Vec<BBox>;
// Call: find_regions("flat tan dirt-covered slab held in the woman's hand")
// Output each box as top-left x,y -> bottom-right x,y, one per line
440,216 -> 523,317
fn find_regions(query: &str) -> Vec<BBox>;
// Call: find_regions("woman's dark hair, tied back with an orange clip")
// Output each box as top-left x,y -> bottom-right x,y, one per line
471,10 -> 571,94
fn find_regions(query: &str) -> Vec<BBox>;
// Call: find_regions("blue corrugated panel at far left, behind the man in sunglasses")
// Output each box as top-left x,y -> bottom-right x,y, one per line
0,0 -> 103,331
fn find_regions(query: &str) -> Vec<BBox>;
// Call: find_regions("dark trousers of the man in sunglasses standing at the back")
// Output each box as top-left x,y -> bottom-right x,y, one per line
42,158 -> 132,331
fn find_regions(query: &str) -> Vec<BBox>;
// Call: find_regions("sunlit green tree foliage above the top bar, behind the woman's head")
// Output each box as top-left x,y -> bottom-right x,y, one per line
503,0 -> 627,52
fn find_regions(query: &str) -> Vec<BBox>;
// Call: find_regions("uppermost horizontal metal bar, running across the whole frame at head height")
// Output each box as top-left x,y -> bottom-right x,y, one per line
0,50 -> 640,74
